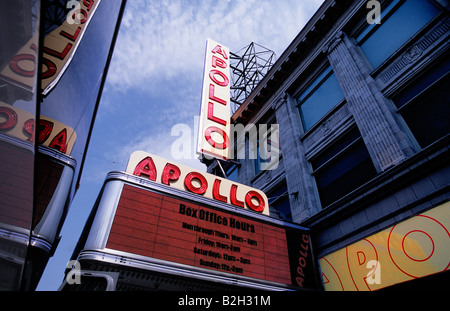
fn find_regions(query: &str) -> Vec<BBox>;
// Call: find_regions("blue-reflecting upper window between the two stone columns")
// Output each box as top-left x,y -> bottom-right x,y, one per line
298,67 -> 344,131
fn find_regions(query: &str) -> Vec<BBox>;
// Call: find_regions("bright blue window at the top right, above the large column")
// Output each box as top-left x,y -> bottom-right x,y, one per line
356,0 -> 440,68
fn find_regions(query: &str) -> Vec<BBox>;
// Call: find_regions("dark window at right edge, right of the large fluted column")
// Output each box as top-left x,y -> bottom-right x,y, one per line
393,58 -> 450,148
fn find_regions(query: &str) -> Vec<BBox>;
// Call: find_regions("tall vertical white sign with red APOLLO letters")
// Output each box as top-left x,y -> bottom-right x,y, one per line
197,39 -> 231,159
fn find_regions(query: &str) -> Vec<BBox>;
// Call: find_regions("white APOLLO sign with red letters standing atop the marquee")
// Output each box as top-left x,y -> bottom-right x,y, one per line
126,151 -> 269,215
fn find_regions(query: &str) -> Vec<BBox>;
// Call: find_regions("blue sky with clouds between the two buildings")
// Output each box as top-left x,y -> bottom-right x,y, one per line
38,0 -> 323,290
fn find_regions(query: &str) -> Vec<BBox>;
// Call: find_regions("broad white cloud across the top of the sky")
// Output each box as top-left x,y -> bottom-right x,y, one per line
108,0 -> 323,91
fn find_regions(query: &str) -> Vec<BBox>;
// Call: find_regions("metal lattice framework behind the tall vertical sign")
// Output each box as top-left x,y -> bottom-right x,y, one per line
230,42 -> 276,113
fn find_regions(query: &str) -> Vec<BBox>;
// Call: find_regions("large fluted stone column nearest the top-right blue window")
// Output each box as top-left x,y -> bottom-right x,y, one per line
326,32 -> 413,172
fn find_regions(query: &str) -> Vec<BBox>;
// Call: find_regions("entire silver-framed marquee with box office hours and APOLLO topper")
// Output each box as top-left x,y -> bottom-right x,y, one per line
67,151 -> 316,290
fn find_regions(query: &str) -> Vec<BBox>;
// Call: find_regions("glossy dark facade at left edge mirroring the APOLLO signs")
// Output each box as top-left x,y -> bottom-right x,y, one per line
0,0 -> 125,290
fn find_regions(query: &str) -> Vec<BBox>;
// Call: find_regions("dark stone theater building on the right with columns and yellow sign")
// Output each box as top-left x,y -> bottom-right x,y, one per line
203,0 -> 450,290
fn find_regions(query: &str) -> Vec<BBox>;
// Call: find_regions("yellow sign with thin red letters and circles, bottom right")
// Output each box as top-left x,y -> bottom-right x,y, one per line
319,202 -> 450,290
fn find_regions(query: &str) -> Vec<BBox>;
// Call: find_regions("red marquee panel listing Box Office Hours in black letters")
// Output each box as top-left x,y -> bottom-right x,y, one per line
106,185 -> 311,287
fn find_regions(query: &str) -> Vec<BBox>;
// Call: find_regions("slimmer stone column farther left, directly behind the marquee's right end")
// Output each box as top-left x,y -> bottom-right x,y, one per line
274,94 -> 321,222
